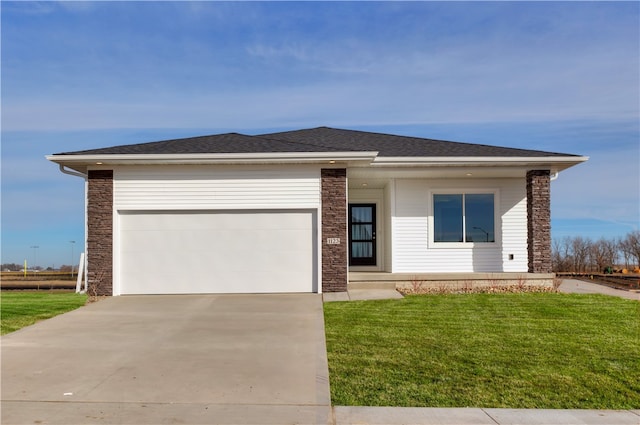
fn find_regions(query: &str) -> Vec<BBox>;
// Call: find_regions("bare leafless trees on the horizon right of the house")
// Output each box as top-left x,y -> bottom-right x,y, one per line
551,230 -> 640,273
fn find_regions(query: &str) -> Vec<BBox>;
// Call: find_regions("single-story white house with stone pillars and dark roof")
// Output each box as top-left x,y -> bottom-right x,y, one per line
47,127 -> 587,295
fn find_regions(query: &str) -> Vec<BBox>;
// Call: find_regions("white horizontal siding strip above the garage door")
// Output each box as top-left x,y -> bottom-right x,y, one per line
114,165 -> 320,210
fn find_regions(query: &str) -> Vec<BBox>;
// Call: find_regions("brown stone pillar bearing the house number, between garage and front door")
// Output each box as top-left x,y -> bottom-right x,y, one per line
321,168 -> 349,292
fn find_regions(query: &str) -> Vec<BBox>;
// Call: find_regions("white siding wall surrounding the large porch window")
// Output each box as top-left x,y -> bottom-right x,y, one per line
392,179 -> 527,273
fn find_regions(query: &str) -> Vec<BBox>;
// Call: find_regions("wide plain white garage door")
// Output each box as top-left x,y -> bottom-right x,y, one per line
119,211 -> 317,294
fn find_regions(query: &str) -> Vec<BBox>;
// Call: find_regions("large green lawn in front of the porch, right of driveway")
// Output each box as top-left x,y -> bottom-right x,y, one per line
324,294 -> 640,409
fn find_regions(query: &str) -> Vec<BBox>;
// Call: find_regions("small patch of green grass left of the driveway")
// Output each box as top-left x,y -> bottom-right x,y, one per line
0,292 -> 87,335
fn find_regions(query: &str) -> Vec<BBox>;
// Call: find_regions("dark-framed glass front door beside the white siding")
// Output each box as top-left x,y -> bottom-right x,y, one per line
349,204 -> 376,266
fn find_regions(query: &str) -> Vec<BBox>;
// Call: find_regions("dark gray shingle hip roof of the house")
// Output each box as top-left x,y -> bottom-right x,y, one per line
55,127 -> 576,157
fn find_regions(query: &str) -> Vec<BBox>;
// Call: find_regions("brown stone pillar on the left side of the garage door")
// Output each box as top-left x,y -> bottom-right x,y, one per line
87,170 -> 113,295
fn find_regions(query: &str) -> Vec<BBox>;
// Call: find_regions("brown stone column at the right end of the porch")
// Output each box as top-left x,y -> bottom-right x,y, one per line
527,170 -> 552,273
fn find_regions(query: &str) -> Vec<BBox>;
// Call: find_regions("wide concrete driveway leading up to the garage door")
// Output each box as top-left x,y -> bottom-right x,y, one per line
1,294 -> 331,424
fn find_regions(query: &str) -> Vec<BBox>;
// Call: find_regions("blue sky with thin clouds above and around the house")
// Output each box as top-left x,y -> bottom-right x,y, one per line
0,1 -> 640,267
